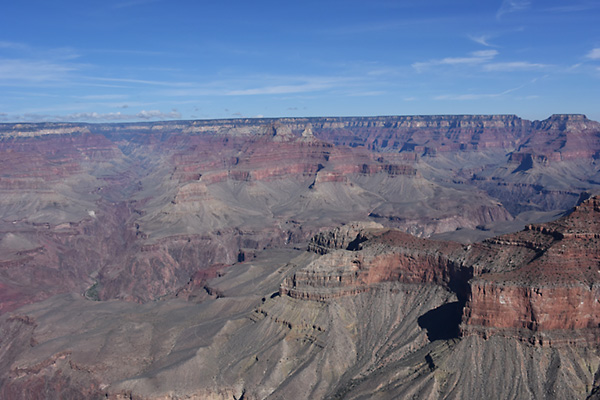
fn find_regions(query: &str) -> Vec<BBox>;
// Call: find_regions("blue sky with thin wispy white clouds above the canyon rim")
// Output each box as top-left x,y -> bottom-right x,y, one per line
0,0 -> 600,122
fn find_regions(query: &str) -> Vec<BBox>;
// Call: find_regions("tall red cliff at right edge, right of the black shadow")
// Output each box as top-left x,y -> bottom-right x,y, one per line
462,197 -> 600,344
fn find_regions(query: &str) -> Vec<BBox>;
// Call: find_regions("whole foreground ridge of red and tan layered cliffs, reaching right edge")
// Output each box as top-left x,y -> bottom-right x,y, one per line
280,197 -> 600,345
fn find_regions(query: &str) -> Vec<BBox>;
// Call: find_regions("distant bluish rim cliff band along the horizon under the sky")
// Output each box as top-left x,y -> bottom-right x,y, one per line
0,114 -> 600,158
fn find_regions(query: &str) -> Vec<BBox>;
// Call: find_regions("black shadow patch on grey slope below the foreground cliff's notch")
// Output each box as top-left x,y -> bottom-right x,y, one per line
417,301 -> 465,342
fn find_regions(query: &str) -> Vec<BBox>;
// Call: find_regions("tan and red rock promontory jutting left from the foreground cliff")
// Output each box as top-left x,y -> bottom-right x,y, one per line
280,224 -> 465,301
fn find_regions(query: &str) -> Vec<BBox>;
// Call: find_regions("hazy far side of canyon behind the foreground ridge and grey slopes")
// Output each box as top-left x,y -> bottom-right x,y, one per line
0,115 -> 598,309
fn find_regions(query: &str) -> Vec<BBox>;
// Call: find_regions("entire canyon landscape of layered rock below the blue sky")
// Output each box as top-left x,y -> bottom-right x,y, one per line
0,115 -> 600,399
